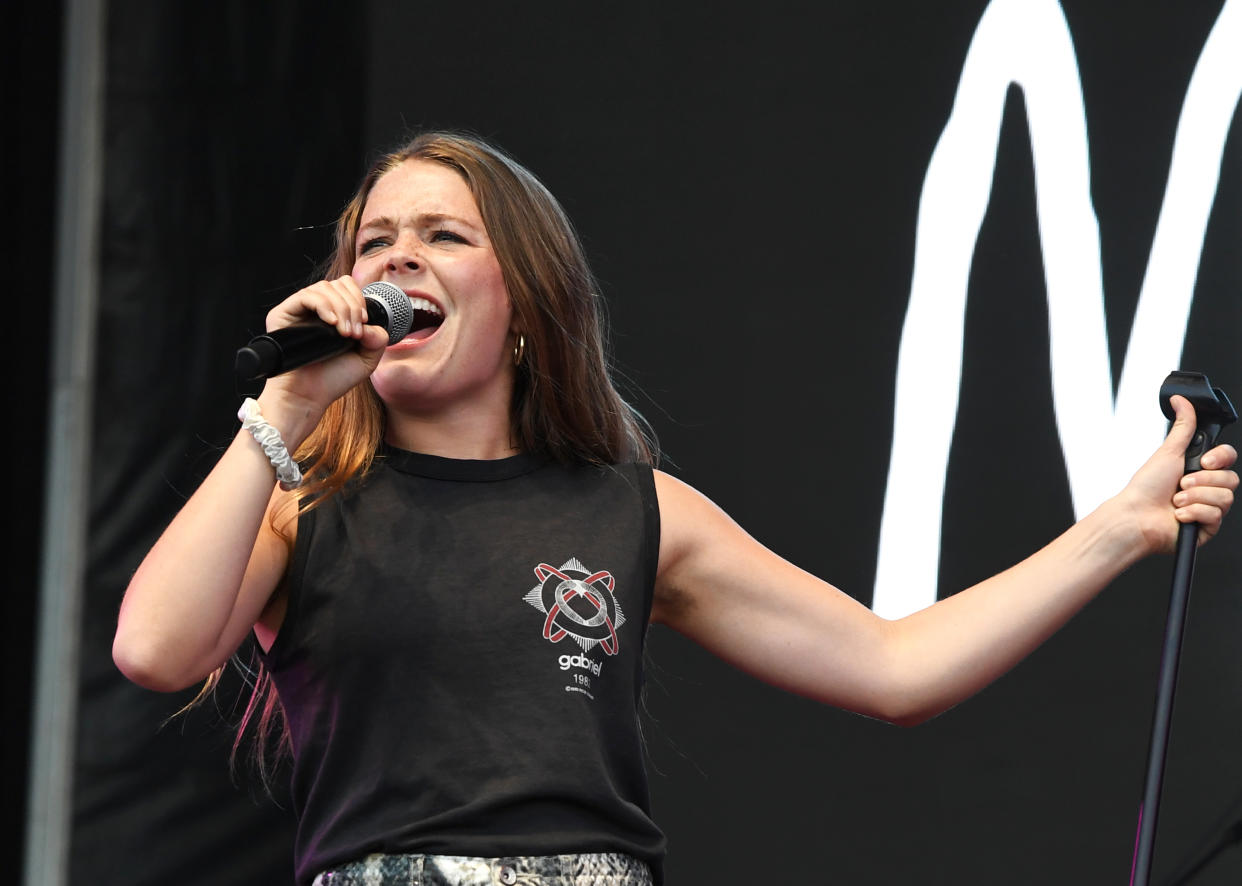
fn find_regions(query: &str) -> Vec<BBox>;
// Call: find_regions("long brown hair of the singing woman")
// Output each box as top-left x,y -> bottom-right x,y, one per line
216,132 -> 658,782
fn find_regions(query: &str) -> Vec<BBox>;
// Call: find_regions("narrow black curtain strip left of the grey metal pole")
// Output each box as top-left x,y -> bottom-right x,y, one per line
7,2 -> 61,866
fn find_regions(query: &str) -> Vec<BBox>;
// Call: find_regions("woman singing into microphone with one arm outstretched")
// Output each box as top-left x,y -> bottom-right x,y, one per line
113,133 -> 1237,886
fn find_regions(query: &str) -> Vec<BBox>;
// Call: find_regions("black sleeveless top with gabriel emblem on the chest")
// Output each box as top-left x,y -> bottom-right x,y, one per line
265,447 -> 664,884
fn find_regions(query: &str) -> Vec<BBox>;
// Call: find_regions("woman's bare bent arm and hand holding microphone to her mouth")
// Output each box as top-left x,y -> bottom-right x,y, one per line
112,277 -> 388,692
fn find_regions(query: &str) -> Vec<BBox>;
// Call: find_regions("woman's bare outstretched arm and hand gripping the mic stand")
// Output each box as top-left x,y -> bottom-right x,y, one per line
652,398 -> 1238,724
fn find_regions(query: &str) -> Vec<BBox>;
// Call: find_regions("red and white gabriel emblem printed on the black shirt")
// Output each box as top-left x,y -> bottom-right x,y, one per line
523,557 -> 625,698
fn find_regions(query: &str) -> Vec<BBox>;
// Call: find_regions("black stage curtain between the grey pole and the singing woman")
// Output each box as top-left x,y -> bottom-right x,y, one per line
72,0 -> 365,886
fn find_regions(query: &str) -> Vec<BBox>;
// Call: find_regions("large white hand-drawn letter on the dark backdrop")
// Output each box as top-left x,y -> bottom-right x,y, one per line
872,0 -> 1242,618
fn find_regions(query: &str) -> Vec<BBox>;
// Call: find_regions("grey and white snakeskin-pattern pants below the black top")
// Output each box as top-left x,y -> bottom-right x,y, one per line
313,852 -> 652,886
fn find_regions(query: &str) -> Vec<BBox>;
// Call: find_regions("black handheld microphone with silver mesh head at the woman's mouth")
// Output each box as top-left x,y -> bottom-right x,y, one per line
233,281 -> 414,381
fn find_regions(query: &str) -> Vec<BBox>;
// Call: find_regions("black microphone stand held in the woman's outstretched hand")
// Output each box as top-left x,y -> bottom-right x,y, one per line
1130,372 -> 1238,886
